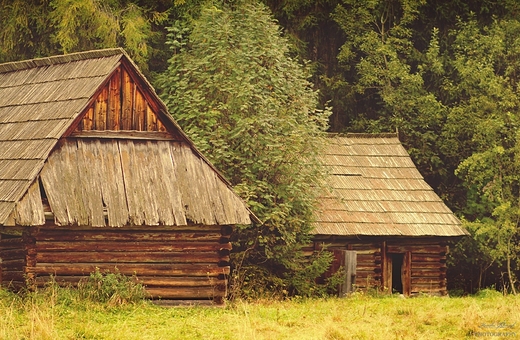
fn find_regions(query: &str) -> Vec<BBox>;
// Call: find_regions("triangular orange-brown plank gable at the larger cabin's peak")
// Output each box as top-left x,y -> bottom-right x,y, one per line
73,64 -> 168,135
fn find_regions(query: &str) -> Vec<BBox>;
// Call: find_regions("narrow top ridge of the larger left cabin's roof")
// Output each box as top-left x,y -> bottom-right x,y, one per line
0,47 -> 128,73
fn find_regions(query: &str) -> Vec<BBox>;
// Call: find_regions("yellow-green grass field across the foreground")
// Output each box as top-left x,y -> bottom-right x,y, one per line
0,289 -> 520,340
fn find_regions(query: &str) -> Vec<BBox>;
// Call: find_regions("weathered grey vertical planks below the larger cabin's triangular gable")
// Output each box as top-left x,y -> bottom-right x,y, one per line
40,138 -> 250,227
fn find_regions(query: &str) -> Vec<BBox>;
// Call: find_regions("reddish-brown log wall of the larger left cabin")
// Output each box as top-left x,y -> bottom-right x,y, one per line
2,226 -> 232,303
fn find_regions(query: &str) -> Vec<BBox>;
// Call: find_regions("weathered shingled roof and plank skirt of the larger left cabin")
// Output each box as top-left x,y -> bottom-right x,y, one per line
0,48 -> 255,226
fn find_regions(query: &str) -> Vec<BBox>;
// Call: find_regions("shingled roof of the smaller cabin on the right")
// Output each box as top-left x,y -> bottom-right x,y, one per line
313,134 -> 467,236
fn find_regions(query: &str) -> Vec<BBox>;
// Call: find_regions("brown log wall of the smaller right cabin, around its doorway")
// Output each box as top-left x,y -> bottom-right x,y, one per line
307,238 -> 448,296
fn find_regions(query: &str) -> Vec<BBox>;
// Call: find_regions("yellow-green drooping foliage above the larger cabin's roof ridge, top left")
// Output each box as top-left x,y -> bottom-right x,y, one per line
0,0 -> 168,70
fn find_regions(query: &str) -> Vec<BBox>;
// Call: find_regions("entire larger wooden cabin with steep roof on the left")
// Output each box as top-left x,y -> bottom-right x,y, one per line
0,49 -> 255,303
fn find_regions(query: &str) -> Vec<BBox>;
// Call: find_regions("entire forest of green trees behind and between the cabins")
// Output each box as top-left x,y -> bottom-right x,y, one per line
0,0 -> 520,295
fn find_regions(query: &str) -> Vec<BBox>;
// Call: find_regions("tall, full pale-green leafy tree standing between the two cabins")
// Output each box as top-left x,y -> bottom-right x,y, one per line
158,1 -> 329,296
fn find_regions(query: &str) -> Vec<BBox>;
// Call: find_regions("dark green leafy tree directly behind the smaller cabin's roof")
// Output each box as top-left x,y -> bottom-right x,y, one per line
333,0 -> 447,183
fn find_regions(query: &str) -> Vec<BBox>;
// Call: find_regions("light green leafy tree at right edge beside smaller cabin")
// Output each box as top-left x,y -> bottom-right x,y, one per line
444,20 -> 520,293
